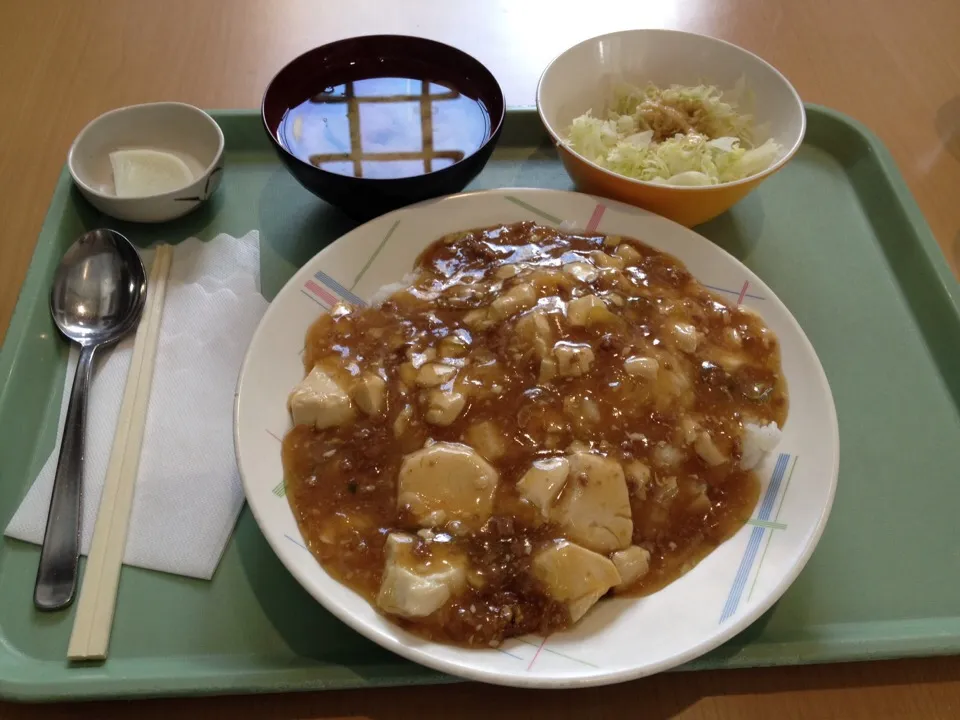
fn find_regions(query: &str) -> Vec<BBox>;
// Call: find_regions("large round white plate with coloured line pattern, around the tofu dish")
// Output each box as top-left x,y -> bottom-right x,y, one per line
234,189 -> 839,687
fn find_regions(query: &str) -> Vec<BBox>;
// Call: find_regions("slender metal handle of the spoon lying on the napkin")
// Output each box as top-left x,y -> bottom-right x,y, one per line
33,345 -> 96,610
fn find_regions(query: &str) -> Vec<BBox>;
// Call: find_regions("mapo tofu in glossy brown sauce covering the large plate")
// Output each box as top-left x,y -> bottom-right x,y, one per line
283,223 -> 787,646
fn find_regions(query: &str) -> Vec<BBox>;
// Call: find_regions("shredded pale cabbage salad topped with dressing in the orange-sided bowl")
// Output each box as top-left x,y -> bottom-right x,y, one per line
566,84 -> 783,186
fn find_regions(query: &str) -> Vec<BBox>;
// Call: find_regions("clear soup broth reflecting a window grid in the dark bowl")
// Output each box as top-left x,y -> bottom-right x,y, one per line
278,77 -> 490,179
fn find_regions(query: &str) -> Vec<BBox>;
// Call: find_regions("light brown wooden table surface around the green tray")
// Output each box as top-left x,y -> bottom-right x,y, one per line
0,0 -> 960,720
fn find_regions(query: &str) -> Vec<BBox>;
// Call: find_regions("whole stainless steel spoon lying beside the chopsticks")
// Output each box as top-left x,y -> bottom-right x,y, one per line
33,230 -> 147,610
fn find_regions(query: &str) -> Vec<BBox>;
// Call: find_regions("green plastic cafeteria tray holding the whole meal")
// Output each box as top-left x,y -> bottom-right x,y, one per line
0,106 -> 960,700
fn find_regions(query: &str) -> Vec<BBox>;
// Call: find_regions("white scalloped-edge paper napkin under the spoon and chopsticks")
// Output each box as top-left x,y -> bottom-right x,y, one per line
6,231 -> 267,579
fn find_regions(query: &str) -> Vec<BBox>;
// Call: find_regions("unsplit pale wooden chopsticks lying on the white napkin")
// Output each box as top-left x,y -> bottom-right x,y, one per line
67,245 -> 173,660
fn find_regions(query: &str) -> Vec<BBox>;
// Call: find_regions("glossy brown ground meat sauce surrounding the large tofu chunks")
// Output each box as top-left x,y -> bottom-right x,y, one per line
283,223 -> 787,646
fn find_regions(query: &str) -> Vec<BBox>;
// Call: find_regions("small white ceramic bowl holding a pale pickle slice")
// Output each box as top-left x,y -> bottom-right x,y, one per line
67,102 -> 223,222
